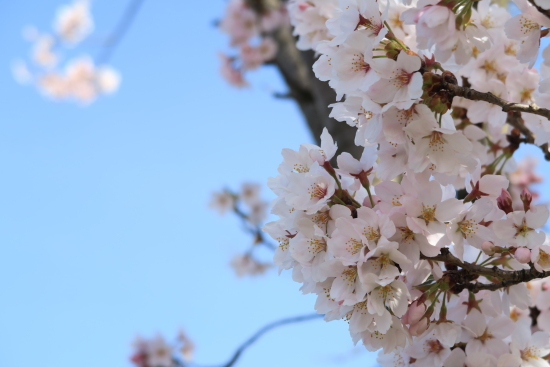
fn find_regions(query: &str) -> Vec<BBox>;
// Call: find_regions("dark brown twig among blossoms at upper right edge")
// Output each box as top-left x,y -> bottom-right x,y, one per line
441,81 -> 550,161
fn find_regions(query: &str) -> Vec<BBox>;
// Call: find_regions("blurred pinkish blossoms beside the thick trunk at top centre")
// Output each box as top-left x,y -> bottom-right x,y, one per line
220,0 -> 288,87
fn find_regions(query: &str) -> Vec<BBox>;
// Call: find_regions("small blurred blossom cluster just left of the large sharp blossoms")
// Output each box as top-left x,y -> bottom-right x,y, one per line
209,182 -> 274,277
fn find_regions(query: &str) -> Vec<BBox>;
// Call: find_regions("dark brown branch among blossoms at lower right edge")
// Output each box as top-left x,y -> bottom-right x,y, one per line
422,248 -> 550,293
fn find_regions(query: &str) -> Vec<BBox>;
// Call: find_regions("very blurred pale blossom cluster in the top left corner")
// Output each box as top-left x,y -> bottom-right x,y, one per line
13,0 -> 120,104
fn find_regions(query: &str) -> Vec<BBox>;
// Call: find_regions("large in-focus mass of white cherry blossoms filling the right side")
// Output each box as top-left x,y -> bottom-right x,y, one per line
264,0 -> 550,367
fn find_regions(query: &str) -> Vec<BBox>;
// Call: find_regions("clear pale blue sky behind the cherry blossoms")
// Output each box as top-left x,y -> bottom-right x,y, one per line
0,0 -> 548,367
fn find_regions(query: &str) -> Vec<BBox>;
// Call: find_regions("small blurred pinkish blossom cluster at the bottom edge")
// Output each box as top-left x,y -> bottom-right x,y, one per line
130,330 -> 195,367
